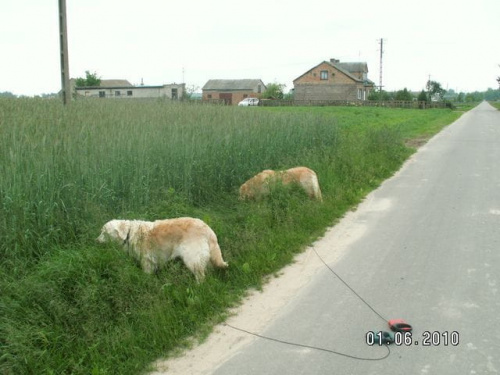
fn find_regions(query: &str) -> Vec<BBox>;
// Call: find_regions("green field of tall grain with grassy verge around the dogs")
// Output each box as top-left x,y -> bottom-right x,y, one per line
0,99 -> 460,374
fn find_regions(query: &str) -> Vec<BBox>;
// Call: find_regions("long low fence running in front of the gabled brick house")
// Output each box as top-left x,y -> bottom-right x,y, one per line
259,100 -> 448,109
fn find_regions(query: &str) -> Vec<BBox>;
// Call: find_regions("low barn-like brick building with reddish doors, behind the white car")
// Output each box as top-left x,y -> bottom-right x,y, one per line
201,79 -> 266,105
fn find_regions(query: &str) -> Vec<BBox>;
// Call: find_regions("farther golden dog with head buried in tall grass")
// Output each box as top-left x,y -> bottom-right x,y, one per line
240,167 -> 323,201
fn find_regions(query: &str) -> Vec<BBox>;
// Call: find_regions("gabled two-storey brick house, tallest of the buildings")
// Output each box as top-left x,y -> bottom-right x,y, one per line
293,59 -> 375,103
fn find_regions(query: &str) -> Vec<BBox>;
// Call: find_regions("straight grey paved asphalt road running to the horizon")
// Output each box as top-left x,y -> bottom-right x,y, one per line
214,103 -> 500,375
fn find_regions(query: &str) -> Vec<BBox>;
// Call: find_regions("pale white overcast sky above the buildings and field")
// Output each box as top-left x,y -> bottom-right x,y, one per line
0,0 -> 500,95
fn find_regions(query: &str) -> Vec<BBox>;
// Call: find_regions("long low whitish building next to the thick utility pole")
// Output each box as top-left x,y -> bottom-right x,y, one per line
70,79 -> 186,100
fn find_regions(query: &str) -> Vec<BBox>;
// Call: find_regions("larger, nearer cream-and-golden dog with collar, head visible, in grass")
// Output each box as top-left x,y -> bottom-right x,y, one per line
97,217 -> 228,282
